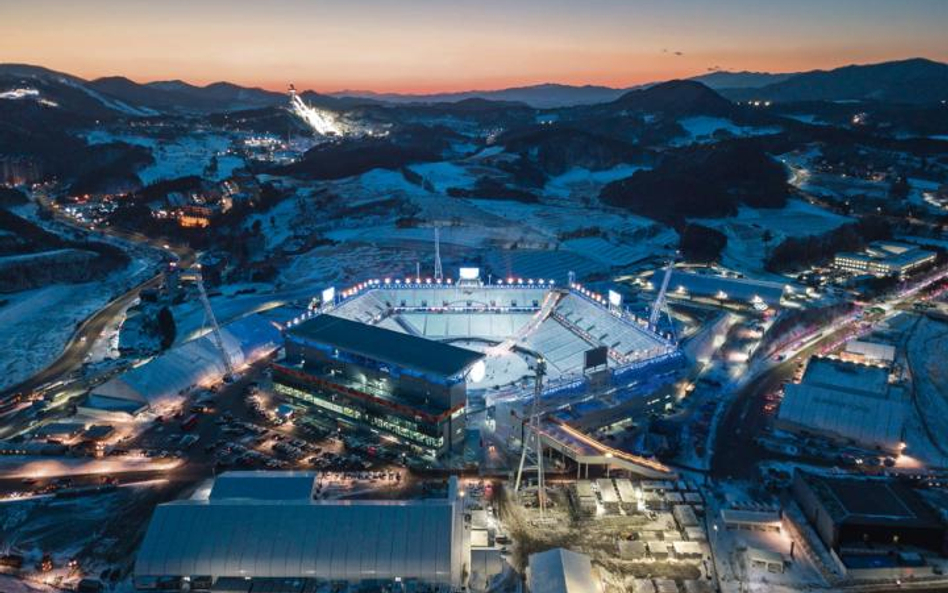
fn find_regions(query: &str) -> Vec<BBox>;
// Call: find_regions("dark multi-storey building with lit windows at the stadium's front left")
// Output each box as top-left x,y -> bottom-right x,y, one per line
273,315 -> 484,456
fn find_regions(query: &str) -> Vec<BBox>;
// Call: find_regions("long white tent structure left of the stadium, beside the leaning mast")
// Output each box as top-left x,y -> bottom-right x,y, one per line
85,314 -> 282,414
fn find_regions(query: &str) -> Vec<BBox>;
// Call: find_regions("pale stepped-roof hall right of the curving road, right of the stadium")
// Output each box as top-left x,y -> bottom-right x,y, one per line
776,358 -> 907,453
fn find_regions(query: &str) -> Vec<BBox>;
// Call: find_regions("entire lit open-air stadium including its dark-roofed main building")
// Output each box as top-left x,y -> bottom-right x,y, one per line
273,268 -> 681,457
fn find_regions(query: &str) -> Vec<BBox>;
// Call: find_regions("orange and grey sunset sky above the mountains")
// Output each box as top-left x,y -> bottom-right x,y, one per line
0,0 -> 948,92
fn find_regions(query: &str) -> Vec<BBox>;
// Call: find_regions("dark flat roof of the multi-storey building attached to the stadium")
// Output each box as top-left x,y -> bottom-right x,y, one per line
288,315 -> 484,377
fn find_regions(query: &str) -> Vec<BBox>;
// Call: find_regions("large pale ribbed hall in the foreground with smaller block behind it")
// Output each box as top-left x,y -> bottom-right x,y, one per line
134,472 -> 470,593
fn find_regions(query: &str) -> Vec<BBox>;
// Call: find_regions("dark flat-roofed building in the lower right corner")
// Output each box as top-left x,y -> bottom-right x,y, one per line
792,470 -> 948,562
